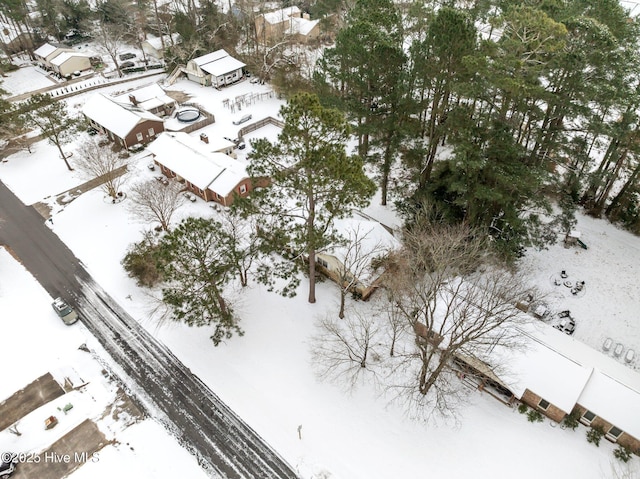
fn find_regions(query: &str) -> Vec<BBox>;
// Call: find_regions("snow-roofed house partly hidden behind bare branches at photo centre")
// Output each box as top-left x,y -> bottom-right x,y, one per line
316,217 -> 400,300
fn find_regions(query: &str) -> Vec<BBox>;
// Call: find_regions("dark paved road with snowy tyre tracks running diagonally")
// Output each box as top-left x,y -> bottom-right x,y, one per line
0,182 -> 297,479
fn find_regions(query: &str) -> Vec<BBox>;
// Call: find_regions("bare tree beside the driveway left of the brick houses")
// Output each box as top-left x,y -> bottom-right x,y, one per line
75,136 -> 128,201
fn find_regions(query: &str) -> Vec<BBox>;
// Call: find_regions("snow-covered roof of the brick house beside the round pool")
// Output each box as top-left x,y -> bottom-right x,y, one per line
82,93 -> 162,138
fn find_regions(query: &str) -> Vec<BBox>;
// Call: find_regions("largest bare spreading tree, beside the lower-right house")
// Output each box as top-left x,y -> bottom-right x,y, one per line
380,221 -> 530,417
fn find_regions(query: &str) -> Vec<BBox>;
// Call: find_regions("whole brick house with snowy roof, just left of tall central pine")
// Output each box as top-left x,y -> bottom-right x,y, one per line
147,132 -> 260,206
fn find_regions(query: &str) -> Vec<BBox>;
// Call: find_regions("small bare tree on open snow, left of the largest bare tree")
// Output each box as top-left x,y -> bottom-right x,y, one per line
311,311 -> 383,387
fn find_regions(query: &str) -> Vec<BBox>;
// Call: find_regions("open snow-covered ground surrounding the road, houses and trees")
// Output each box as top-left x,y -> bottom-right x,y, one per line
0,72 -> 640,479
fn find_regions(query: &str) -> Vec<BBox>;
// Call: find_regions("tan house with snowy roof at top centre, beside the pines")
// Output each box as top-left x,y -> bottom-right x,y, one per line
255,6 -> 320,45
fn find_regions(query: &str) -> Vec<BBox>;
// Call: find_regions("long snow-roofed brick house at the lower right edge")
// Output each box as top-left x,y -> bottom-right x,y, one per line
459,322 -> 640,451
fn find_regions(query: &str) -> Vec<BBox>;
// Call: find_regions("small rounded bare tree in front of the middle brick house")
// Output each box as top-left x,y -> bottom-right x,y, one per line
129,180 -> 185,231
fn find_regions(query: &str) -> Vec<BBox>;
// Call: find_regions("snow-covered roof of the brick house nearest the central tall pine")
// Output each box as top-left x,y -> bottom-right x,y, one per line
147,132 -> 249,197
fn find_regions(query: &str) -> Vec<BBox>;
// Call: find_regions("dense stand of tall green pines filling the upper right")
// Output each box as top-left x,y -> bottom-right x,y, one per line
314,0 -> 640,258
